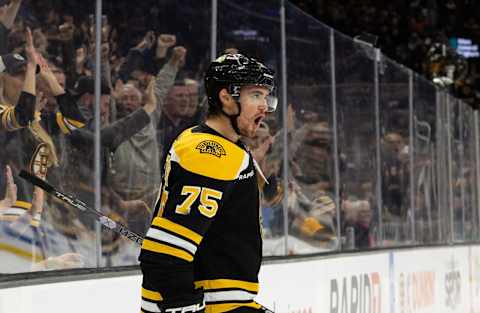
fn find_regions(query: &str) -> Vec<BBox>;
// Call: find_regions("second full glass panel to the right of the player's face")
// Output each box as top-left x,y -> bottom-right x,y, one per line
335,33 -> 379,249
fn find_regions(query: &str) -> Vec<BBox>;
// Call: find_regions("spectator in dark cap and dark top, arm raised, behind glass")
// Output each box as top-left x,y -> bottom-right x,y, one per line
52,76 -> 152,212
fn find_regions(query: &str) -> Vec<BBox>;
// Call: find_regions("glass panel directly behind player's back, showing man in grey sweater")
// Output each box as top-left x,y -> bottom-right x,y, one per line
101,0 -> 211,266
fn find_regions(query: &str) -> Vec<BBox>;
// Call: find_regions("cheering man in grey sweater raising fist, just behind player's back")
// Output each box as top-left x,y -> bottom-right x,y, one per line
108,47 -> 186,232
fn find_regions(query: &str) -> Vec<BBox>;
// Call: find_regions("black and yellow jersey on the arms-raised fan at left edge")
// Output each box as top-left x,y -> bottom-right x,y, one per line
0,92 -> 85,227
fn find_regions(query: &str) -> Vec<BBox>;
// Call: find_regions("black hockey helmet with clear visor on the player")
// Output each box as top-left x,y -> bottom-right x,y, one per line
205,54 -> 278,112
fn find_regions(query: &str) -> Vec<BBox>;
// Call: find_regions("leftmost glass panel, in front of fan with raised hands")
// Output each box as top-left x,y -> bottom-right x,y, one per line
0,0 -> 97,273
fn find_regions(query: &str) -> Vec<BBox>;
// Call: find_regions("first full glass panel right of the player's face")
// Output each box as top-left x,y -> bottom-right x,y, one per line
286,4 -> 339,253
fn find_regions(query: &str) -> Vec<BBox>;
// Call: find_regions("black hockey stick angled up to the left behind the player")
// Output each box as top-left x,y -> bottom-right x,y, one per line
19,170 -> 143,245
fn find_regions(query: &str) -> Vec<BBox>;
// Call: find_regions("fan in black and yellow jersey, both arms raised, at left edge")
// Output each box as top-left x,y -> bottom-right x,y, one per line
0,37 -> 103,255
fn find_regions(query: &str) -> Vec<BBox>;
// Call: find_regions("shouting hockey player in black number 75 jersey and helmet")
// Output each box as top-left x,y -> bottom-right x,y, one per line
140,54 -> 277,313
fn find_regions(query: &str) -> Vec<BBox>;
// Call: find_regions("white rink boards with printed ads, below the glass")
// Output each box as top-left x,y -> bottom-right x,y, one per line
0,246 -> 480,313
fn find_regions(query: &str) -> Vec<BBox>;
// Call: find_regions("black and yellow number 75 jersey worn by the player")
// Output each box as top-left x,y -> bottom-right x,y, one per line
140,124 -> 262,313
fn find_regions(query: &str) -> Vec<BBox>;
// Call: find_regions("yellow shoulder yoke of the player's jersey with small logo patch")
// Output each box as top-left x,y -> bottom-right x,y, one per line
171,129 -> 248,180
